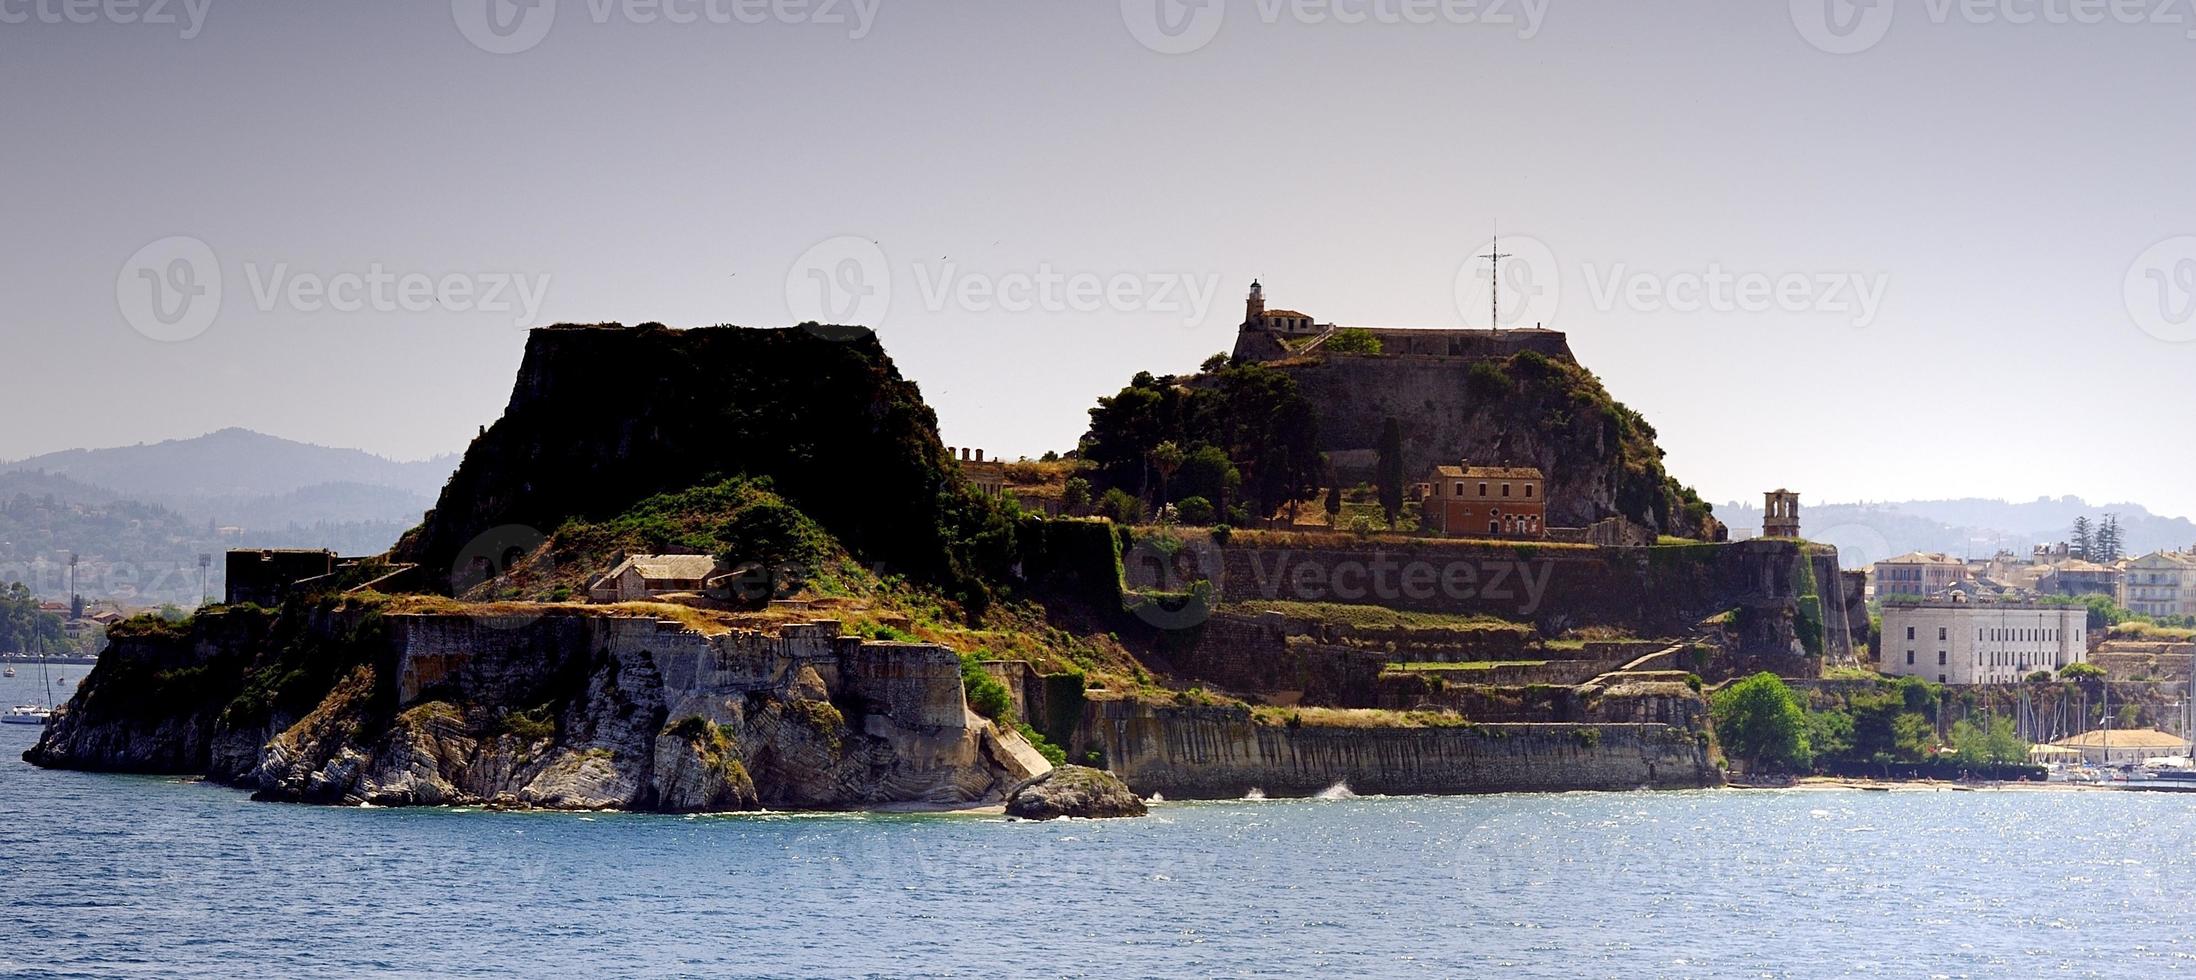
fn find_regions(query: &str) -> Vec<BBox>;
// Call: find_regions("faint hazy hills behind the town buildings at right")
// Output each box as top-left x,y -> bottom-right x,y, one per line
1715,497 -> 2196,569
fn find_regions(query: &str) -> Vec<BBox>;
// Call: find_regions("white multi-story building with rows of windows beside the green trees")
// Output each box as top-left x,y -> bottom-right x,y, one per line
1880,602 -> 2088,683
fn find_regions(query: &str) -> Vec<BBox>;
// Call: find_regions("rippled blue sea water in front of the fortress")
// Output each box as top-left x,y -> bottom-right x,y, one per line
0,668 -> 2196,978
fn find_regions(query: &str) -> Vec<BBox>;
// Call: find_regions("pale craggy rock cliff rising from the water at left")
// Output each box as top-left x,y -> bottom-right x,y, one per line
24,609 -> 1045,811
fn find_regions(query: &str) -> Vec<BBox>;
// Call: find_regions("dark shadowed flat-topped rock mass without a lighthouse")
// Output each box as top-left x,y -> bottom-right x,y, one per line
395,323 -> 1006,606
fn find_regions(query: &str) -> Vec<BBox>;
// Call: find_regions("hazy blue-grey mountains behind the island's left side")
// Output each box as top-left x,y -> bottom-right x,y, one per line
0,428 -> 457,604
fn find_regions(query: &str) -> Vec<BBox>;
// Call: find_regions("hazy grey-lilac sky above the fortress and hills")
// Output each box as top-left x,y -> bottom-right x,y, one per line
0,0 -> 2196,514
